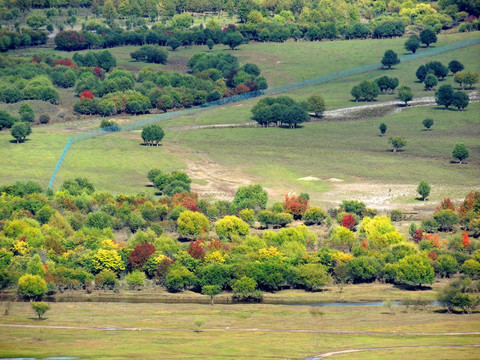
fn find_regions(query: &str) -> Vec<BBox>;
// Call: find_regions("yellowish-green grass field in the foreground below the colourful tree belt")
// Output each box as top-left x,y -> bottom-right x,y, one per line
0,303 -> 480,359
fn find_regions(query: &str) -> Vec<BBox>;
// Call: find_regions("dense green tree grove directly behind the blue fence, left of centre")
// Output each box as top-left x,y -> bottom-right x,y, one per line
74,53 -> 267,116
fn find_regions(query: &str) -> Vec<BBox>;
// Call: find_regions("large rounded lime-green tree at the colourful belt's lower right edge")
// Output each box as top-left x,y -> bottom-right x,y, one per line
396,255 -> 435,286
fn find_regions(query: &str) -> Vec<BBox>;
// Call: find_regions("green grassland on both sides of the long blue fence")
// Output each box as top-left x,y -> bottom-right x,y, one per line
0,33 -> 480,203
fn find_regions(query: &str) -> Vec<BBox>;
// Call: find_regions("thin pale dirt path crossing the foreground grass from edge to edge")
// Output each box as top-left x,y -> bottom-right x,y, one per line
0,324 -> 480,338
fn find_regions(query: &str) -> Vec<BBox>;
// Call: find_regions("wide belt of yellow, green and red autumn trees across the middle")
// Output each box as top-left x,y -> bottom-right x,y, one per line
0,179 -> 480,304
